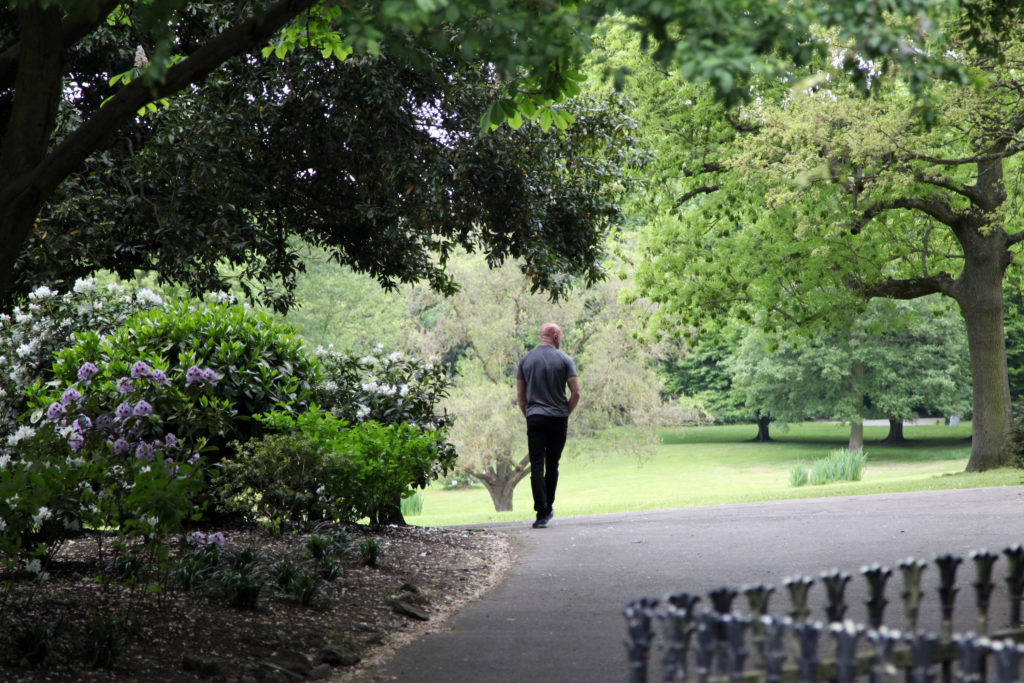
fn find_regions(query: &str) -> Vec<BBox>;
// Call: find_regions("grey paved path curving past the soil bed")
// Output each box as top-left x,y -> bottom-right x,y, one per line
360,486 -> 1024,683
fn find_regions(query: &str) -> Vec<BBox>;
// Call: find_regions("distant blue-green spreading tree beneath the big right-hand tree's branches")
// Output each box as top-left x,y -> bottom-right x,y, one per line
727,300 -> 970,451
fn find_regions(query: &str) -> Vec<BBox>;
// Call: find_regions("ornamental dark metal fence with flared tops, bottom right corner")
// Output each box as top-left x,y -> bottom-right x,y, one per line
624,545 -> 1024,683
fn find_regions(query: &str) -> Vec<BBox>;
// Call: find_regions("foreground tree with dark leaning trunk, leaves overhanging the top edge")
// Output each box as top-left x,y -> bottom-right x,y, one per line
0,0 -> 991,301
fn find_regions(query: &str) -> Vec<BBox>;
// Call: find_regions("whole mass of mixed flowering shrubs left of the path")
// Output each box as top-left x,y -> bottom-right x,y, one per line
0,281 -> 456,679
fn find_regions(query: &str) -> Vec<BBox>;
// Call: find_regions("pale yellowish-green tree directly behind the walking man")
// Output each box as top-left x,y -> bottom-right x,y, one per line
409,250 -> 696,510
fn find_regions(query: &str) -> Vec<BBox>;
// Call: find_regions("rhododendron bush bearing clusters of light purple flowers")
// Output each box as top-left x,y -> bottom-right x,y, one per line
18,358 -> 227,538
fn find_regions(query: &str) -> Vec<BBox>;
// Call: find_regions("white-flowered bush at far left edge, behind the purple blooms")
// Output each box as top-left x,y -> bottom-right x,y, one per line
0,279 -> 163,454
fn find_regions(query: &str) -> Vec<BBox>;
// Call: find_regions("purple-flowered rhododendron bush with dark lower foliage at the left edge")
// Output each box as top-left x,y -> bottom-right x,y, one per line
0,360 -> 227,581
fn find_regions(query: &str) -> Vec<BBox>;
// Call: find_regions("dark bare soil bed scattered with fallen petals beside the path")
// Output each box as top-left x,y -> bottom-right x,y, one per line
0,525 -> 510,682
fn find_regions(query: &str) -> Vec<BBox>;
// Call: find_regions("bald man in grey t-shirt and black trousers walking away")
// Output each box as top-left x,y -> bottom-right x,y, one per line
515,323 -> 580,528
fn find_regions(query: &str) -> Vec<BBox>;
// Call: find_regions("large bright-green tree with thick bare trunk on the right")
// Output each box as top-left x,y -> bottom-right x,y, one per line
634,11 -> 1024,470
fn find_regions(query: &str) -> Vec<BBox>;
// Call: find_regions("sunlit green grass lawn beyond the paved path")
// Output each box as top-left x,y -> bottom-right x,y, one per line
407,423 -> 1024,526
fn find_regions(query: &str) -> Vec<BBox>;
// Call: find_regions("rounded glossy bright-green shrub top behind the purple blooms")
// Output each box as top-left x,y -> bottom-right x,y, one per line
53,300 -> 318,454
